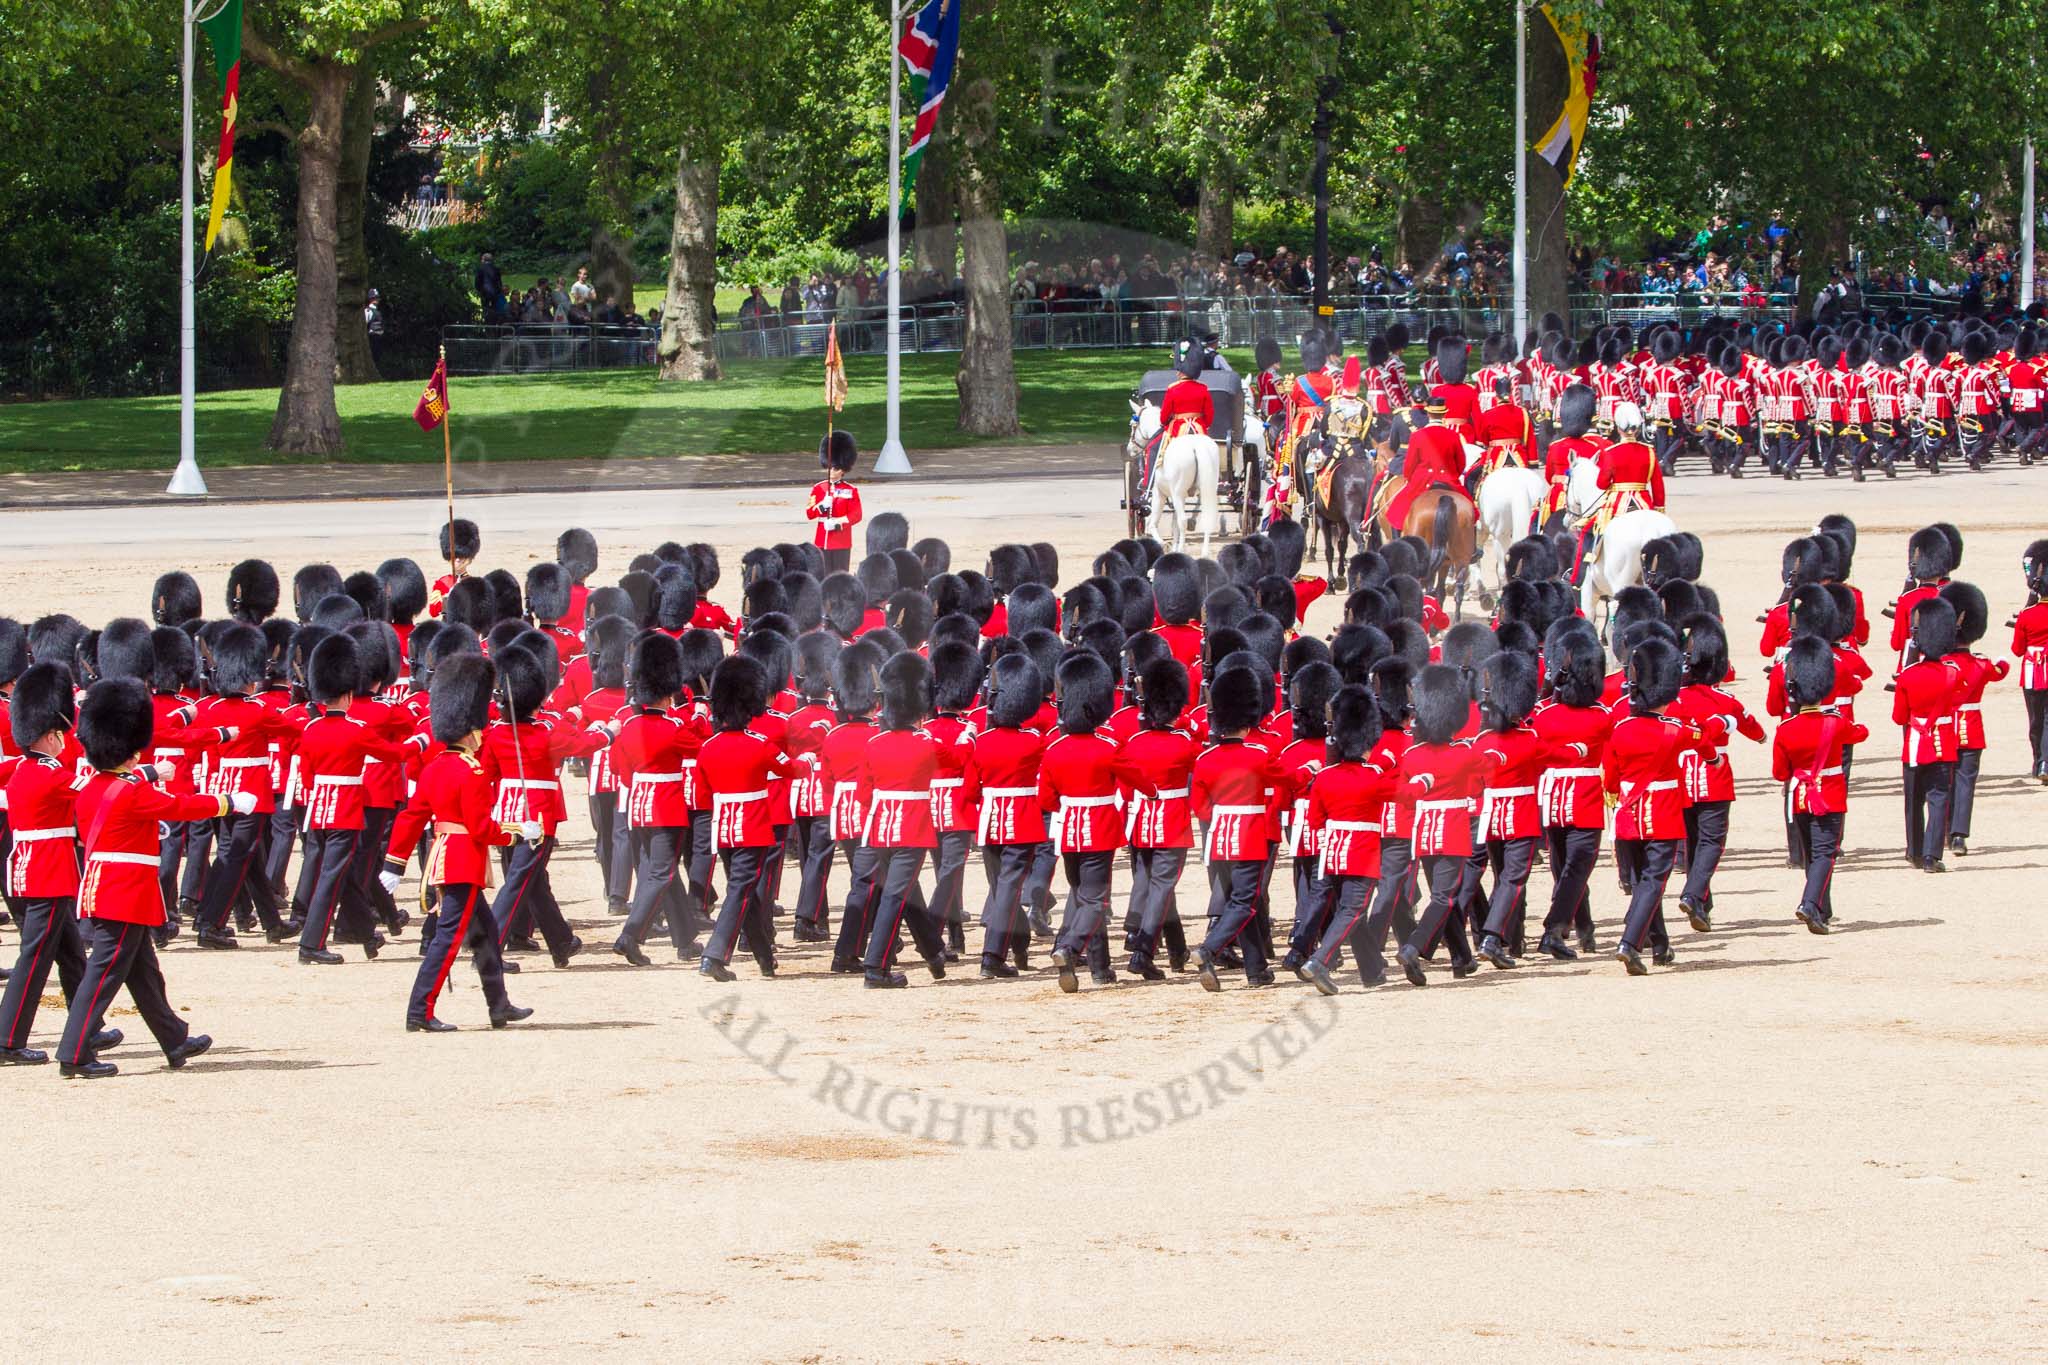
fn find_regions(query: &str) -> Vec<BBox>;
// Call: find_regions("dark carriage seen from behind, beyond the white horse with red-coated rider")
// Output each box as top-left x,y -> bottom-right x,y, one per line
1122,370 -> 1266,542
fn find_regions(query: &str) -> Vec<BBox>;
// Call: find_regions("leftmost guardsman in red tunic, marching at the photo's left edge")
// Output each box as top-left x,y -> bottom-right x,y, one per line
0,663 -> 121,1066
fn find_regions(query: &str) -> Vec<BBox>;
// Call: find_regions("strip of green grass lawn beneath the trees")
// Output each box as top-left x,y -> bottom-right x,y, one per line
0,350 -> 1167,473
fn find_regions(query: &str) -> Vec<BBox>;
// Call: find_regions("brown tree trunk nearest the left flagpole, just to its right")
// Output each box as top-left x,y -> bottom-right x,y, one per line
264,61 -> 352,454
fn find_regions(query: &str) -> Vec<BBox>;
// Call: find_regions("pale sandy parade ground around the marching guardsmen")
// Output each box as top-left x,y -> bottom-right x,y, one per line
0,467 -> 2048,1361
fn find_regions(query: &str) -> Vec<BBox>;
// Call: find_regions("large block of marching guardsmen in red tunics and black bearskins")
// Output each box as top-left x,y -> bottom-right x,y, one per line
0,386 -> 2048,1076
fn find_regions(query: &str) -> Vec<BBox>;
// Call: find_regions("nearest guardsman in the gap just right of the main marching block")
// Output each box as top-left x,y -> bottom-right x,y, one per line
1772,634 -> 1870,933
